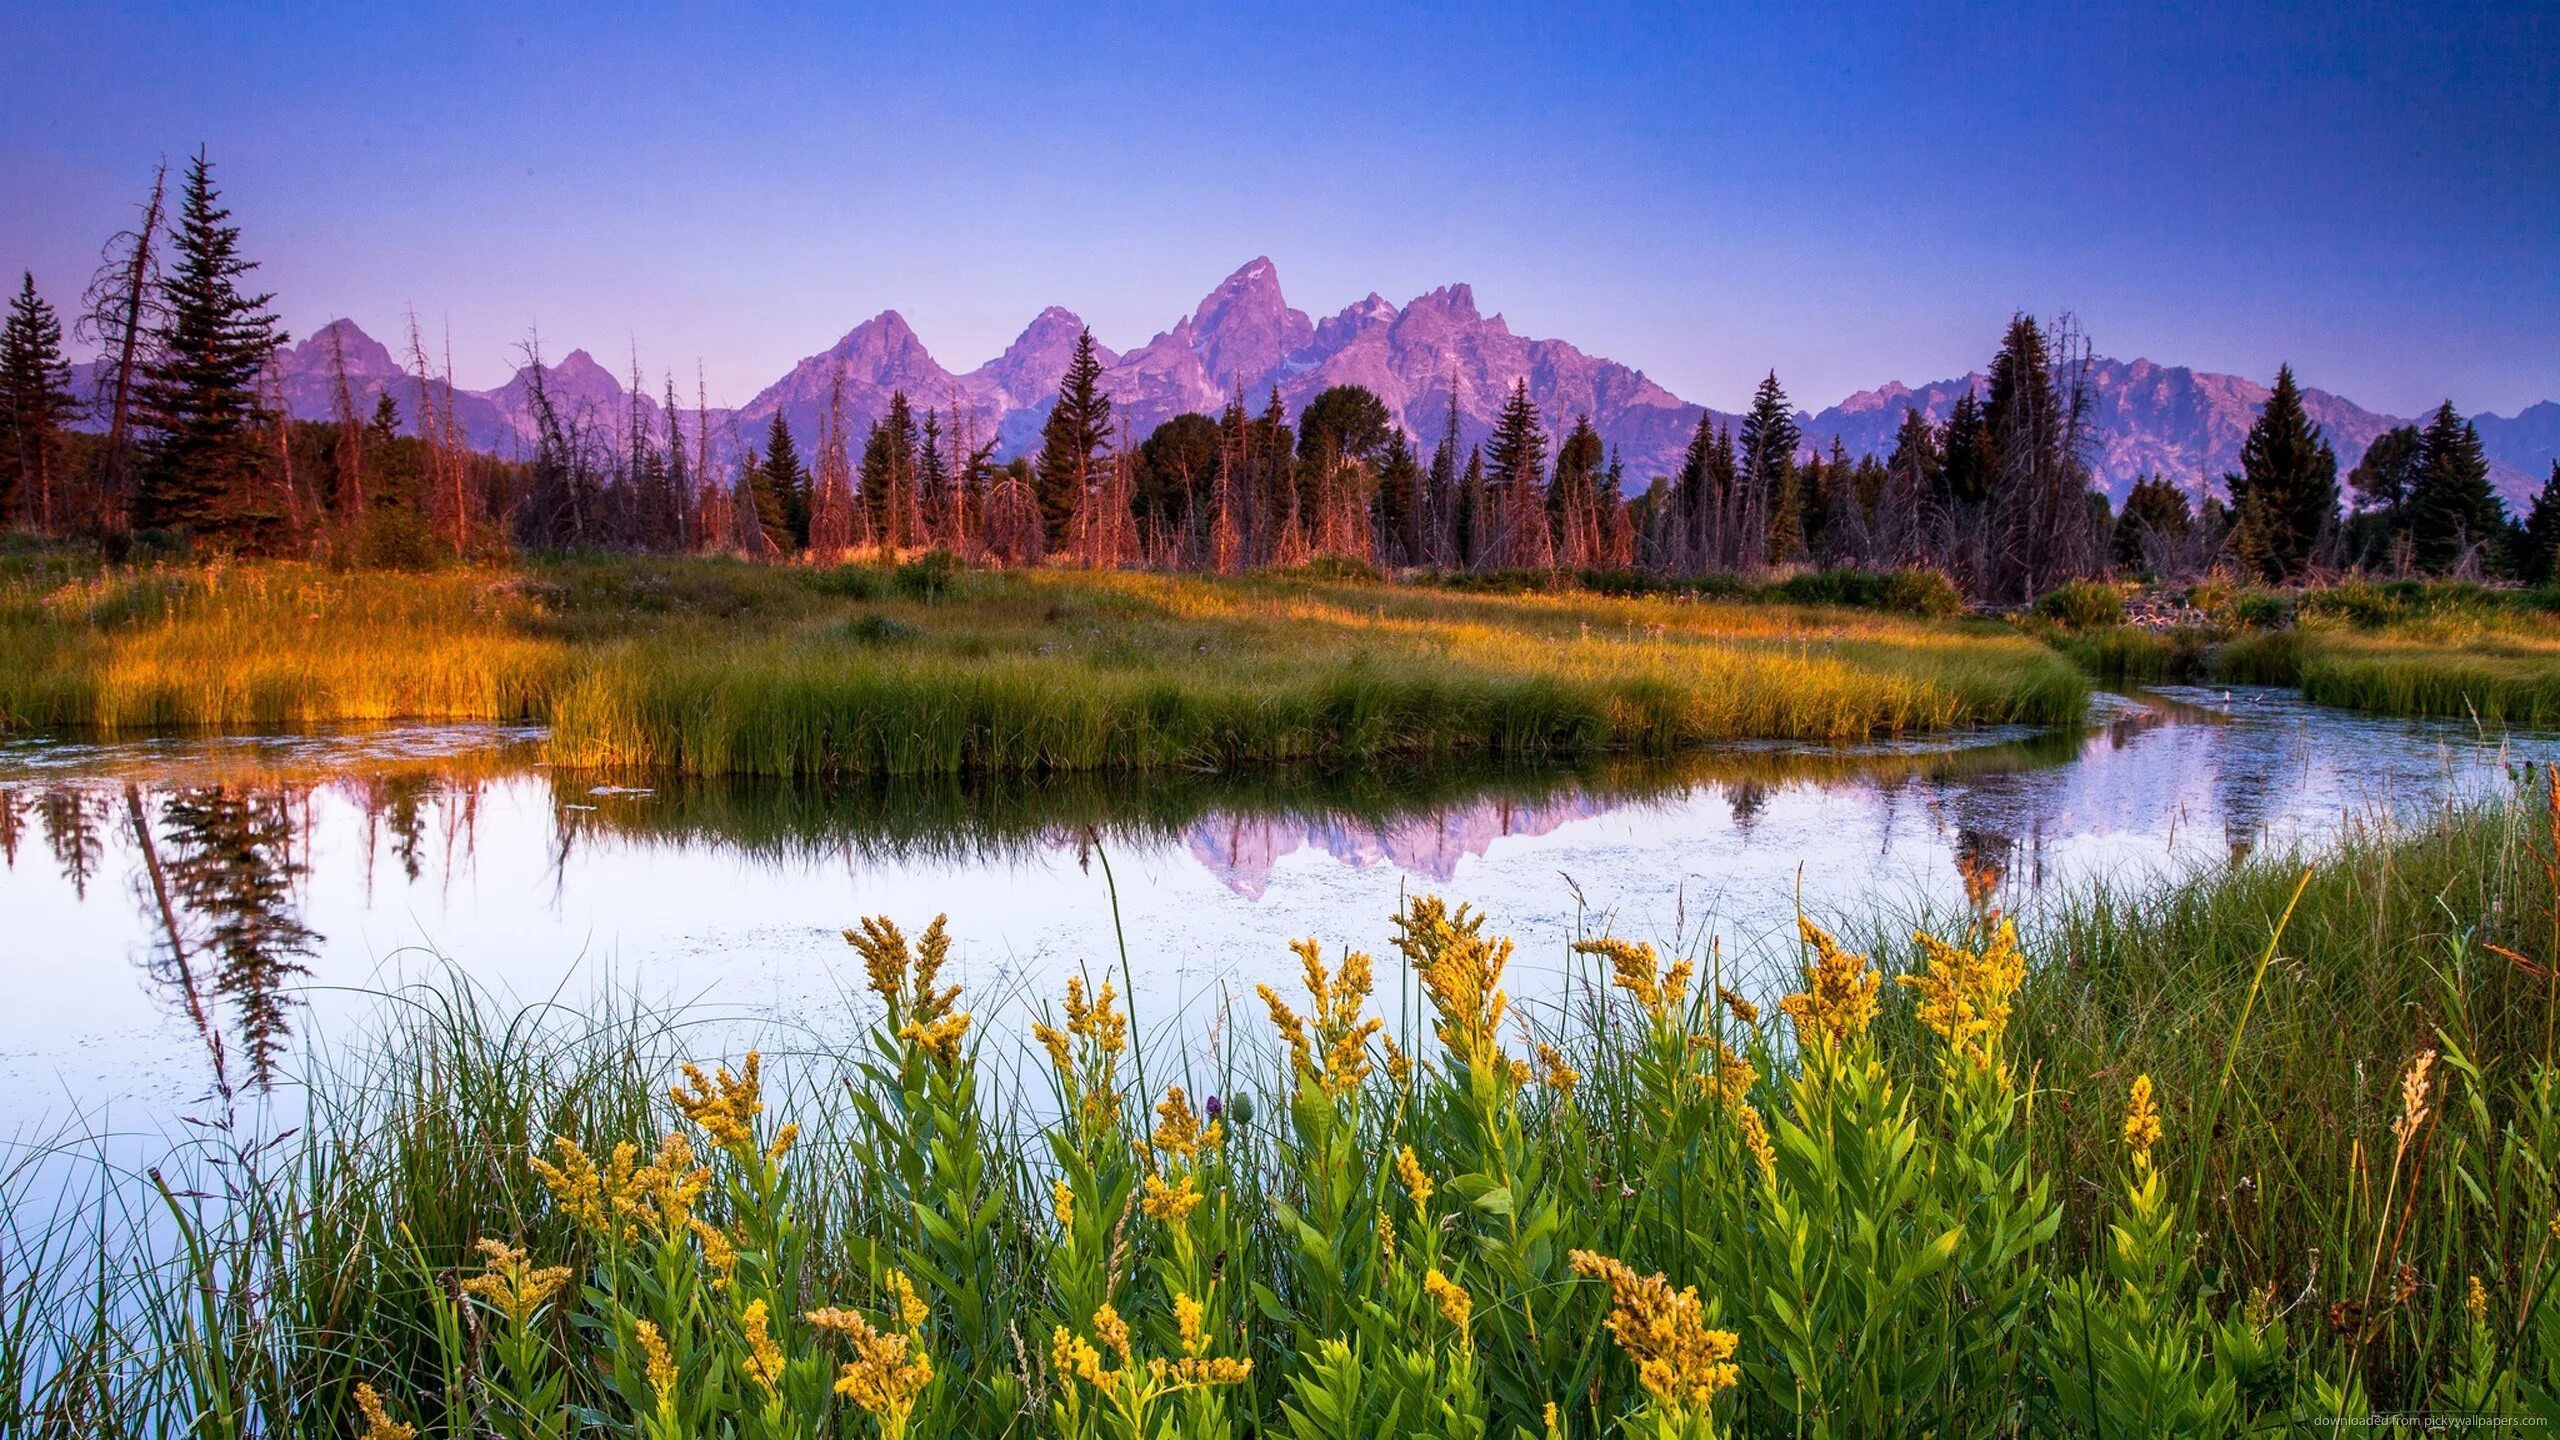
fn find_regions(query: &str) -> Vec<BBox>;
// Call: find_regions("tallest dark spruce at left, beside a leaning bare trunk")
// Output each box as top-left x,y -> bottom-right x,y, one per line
133,151 -> 287,546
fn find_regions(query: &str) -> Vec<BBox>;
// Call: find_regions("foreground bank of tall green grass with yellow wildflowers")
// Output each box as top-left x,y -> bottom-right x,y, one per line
0,776 -> 2560,1440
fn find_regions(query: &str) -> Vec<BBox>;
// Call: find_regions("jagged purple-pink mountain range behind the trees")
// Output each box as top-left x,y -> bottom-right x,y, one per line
110,259 -> 2560,505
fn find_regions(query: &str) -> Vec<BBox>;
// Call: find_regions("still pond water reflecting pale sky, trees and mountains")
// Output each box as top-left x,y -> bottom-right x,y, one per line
0,689 -> 2560,1135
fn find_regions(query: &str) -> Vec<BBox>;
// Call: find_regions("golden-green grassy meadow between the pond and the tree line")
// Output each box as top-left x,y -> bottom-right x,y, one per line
0,556 -> 2086,776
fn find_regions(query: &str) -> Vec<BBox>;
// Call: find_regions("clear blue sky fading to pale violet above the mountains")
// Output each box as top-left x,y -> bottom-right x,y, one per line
0,0 -> 2560,413
